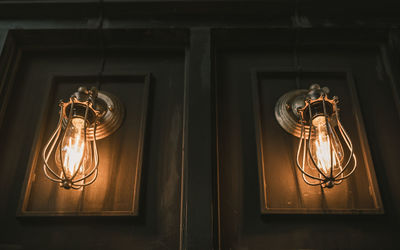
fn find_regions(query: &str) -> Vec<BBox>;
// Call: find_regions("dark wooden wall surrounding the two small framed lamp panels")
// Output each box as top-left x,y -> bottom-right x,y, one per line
0,0 -> 400,249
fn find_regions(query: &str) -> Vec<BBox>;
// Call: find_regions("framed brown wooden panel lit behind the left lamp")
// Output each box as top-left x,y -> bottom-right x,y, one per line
20,74 -> 150,216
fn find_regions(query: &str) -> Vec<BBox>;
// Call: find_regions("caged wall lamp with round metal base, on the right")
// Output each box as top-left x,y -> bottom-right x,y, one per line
275,84 -> 357,188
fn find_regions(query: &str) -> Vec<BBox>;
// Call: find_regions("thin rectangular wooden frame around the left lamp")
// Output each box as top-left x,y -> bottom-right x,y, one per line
17,73 -> 151,217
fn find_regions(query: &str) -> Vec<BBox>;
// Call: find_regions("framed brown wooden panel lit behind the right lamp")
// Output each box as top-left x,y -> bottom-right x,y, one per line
253,69 -> 383,214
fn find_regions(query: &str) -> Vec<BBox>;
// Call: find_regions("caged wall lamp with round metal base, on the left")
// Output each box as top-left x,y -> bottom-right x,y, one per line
42,87 -> 124,189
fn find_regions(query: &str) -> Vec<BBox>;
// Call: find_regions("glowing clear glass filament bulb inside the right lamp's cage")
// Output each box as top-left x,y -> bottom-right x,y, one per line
309,116 -> 344,176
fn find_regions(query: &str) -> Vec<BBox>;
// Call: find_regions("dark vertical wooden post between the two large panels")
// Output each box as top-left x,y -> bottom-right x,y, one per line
182,28 -> 214,249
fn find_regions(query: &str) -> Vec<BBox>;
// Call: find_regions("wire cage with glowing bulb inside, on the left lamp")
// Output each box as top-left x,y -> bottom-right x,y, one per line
42,88 -> 102,189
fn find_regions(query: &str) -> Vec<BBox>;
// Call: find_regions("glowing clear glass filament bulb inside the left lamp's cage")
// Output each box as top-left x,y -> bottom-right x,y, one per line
55,117 -> 92,179
